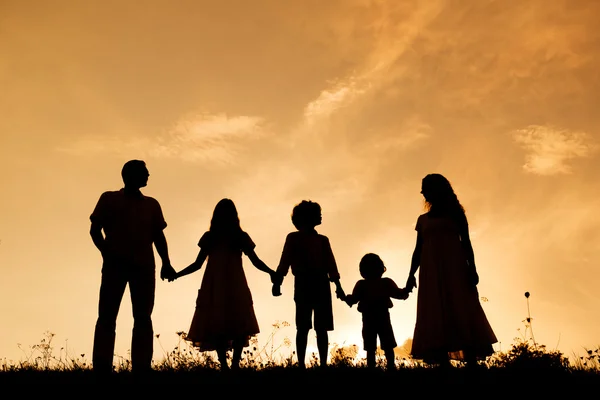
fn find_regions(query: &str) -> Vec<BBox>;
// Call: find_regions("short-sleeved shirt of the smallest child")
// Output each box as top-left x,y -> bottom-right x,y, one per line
352,278 -> 400,313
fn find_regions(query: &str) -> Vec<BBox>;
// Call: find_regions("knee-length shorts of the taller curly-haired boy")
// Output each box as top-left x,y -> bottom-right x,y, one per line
294,276 -> 333,331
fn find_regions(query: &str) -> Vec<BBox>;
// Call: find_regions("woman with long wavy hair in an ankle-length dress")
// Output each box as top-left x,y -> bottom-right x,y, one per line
406,174 -> 497,366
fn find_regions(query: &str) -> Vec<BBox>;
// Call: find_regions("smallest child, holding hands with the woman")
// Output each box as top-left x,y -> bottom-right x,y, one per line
344,253 -> 411,370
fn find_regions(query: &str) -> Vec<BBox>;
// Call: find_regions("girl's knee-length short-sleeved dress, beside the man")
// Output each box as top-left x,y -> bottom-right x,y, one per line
186,231 -> 260,351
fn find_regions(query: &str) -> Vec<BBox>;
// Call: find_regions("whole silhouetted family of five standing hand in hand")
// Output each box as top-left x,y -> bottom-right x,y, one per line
90,160 -> 497,374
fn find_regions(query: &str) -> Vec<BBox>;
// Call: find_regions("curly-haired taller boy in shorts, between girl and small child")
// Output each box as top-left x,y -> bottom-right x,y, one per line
273,200 -> 345,369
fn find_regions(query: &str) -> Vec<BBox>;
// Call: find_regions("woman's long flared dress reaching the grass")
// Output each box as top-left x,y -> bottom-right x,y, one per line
411,214 -> 497,360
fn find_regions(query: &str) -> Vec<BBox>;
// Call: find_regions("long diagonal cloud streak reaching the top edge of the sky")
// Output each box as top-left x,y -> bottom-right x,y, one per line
296,0 -> 444,136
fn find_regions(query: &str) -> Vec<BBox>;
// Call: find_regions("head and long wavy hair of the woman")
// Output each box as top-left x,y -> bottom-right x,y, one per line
422,174 -> 467,222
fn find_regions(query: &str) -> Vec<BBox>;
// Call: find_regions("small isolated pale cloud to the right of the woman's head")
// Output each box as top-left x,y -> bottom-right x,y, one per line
512,125 -> 594,175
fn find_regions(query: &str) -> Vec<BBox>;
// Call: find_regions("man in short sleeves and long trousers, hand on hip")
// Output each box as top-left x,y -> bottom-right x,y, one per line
90,160 -> 175,375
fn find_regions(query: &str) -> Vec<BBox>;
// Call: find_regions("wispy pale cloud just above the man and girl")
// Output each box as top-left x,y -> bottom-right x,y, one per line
57,113 -> 265,164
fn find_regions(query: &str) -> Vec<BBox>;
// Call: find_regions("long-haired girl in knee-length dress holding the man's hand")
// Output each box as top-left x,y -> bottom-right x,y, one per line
174,199 -> 275,370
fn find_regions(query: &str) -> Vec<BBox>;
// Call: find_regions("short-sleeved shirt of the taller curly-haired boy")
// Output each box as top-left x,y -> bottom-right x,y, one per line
277,230 -> 340,281
